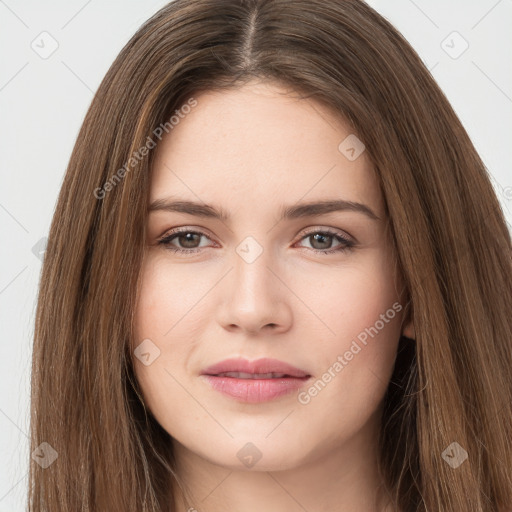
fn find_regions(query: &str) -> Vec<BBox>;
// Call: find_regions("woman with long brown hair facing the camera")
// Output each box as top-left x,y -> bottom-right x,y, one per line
30,0 -> 512,512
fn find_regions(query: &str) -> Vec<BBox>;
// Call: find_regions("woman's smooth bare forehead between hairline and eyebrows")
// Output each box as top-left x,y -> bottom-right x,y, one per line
150,83 -> 383,220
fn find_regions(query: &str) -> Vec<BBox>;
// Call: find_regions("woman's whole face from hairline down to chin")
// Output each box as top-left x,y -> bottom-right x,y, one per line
132,82 -> 412,470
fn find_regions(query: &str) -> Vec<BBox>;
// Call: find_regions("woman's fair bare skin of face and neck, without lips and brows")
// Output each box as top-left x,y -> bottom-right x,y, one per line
133,82 -> 414,512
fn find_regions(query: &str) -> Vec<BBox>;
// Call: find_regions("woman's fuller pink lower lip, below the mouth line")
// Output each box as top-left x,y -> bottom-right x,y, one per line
203,375 -> 310,403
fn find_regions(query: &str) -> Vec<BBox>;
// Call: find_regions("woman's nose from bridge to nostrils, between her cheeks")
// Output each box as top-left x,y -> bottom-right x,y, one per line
217,244 -> 293,335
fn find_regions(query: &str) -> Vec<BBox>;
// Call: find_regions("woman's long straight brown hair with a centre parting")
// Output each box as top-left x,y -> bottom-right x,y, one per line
29,0 -> 512,512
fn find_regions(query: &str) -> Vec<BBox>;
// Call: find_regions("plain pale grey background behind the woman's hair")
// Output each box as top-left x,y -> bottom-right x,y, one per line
0,0 -> 512,512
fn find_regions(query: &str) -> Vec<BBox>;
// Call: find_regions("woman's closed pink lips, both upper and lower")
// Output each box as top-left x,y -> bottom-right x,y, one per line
201,358 -> 311,403
